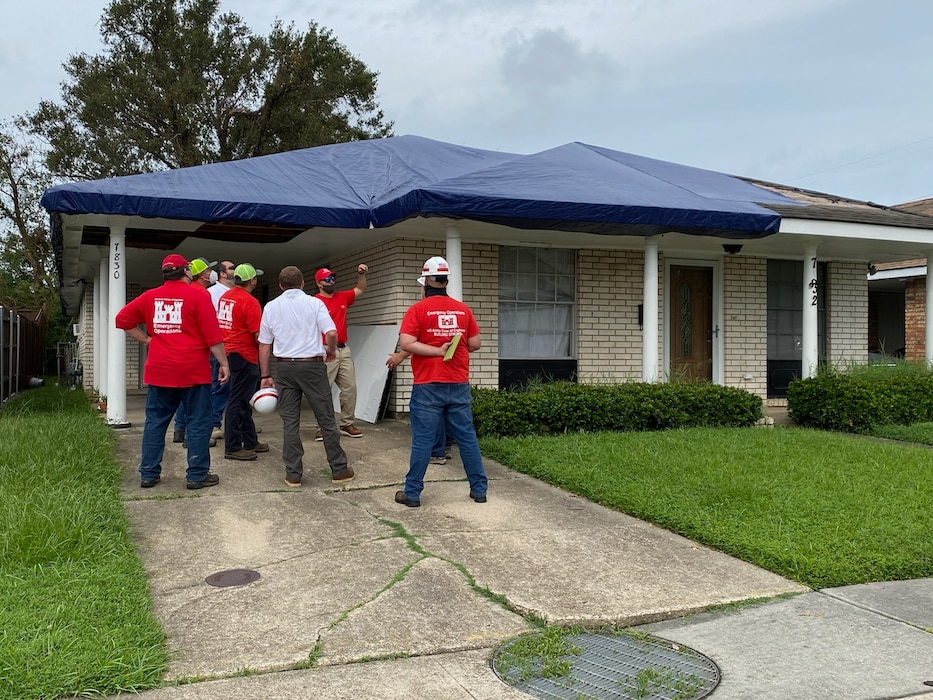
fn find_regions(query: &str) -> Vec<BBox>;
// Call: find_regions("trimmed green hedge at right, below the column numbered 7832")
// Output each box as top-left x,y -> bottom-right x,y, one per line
787,367 -> 933,433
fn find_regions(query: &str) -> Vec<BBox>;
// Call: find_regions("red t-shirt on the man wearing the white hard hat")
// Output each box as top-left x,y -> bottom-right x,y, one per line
399,295 -> 479,384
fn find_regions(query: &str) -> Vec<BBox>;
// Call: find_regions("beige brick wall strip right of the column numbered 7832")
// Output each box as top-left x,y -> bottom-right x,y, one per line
826,262 -> 868,367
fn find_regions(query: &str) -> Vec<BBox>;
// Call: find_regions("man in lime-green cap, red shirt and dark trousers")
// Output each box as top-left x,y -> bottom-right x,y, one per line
217,263 -> 269,461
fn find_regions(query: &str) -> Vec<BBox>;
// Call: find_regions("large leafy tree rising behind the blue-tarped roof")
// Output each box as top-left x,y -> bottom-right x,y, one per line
30,0 -> 392,179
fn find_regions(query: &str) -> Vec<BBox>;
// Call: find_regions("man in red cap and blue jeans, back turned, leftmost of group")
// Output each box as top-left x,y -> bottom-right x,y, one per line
115,255 -> 230,489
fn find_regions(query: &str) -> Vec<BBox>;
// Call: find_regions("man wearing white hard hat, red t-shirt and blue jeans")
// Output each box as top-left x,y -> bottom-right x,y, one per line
395,257 -> 487,508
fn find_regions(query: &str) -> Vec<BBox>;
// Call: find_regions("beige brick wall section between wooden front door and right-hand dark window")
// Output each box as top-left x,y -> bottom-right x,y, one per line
723,257 -> 768,398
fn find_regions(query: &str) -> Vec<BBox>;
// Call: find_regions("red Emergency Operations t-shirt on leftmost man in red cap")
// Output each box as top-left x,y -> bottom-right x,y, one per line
115,280 -> 223,387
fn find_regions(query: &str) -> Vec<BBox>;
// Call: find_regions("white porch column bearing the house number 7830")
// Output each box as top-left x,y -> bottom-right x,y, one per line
107,217 -> 127,426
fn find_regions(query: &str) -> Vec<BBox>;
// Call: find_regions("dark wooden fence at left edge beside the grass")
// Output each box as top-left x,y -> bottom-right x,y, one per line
0,306 -> 47,403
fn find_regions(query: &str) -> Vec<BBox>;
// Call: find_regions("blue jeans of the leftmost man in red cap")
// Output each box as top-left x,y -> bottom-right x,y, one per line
139,384 -> 211,481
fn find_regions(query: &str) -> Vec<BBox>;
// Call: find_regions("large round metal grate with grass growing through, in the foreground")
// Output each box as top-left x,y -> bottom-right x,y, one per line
492,628 -> 720,700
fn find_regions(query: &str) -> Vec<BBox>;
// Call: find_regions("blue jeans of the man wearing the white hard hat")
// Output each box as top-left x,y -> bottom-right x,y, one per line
405,382 -> 487,501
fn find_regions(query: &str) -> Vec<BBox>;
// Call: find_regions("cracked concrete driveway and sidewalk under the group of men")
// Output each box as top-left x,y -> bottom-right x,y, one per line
111,396 -> 933,700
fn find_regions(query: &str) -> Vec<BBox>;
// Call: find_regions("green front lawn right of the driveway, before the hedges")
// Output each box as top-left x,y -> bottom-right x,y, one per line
481,428 -> 933,588
